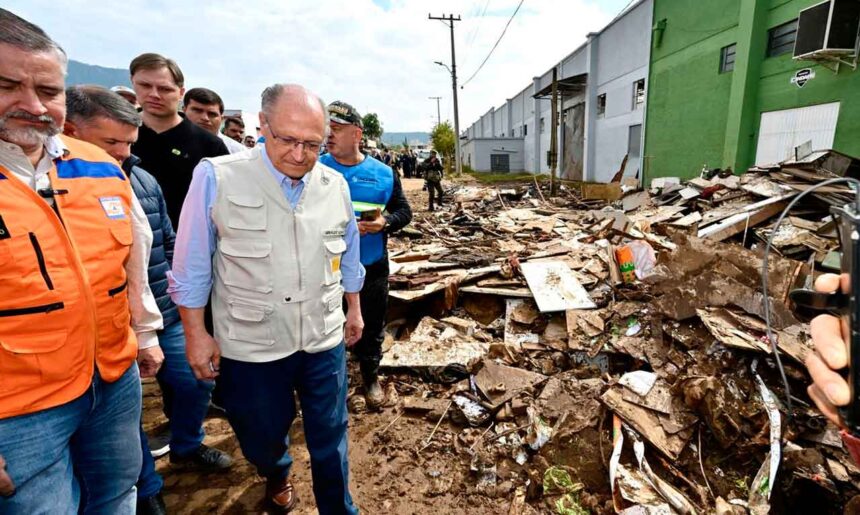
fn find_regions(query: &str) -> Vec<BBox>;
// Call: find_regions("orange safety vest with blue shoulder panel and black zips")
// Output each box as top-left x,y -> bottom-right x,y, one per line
0,137 -> 137,419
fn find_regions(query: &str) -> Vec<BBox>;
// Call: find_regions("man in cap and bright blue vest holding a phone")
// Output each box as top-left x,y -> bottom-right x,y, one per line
320,102 -> 412,408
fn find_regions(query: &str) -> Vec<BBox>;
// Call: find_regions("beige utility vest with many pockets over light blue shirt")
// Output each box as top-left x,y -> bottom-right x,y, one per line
210,148 -> 353,363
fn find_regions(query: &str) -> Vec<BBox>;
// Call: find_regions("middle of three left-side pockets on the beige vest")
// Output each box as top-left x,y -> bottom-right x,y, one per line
218,239 -> 272,293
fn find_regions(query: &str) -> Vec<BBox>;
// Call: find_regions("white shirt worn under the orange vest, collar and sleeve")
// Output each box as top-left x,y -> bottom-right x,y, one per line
0,136 -> 164,349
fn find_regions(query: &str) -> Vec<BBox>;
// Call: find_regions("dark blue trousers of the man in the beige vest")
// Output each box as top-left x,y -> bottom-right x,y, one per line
218,343 -> 358,515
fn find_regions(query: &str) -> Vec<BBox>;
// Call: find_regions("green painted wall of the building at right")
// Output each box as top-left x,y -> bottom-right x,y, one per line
644,0 -> 860,184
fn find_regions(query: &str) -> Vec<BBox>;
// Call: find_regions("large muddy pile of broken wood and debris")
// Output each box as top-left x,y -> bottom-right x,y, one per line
374,153 -> 860,514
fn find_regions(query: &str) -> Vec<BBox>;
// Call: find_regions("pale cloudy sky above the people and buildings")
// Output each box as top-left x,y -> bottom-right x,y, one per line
3,0 -> 628,132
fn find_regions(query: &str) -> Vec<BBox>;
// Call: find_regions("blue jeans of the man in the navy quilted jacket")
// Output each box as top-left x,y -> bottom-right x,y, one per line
137,321 -> 214,498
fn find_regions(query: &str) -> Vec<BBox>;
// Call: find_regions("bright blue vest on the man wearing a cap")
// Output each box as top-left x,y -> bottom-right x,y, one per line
320,154 -> 394,266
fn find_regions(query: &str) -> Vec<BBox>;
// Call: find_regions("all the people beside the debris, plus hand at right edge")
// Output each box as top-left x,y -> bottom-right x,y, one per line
0,4 -> 852,515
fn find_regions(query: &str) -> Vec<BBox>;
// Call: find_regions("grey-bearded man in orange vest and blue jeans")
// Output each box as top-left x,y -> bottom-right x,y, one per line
0,9 -> 162,515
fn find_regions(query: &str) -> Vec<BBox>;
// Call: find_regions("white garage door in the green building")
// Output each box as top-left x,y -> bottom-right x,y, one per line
755,102 -> 839,165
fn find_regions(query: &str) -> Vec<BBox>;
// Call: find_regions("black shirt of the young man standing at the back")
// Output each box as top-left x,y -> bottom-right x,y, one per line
131,117 -> 229,227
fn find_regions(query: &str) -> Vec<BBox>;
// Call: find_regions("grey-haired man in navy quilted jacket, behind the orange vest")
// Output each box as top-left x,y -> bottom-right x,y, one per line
64,86 -> 232,514
